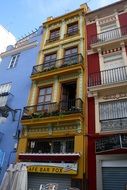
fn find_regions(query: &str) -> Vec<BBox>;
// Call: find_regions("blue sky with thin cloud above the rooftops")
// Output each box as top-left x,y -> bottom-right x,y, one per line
0,0 -> 118,40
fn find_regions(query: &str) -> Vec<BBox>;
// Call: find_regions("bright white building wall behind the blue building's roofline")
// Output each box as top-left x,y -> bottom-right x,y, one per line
0,25 -> 16,53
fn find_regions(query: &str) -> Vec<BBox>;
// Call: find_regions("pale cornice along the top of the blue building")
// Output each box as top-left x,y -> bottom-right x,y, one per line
0,41 -> 38,58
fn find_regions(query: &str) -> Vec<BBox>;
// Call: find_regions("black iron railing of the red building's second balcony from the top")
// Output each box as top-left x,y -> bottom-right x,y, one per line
88,66 -> 127,87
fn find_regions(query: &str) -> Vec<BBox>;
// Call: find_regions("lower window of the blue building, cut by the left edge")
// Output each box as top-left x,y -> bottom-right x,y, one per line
0,83 -> 11,107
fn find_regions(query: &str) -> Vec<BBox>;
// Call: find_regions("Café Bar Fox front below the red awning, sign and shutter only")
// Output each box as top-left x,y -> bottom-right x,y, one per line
17,162 -> 84,190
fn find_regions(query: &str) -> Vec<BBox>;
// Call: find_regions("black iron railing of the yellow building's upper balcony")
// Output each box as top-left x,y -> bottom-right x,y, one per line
32,54 -> 83,75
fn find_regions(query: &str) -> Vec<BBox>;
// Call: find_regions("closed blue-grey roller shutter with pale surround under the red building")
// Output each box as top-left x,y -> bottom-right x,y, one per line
96,154 -> 127,190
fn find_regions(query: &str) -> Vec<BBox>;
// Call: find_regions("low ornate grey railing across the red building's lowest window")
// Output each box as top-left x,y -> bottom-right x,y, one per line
101,118 -> 127,132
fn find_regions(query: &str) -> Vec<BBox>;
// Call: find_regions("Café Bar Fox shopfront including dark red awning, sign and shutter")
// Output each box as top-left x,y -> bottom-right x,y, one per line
19,153 -> 80,190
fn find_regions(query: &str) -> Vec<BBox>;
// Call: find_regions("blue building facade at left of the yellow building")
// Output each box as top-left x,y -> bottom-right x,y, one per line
0,27 -> 42,182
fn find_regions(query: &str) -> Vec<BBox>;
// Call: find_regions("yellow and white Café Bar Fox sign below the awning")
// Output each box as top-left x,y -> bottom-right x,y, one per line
27,163 -> 77,174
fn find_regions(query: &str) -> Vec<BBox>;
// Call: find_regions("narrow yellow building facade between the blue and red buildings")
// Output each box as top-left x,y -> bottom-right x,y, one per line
17,4 -> 87,190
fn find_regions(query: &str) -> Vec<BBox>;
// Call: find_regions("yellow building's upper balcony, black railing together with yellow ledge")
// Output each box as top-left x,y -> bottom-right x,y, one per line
31,54 -> 83,80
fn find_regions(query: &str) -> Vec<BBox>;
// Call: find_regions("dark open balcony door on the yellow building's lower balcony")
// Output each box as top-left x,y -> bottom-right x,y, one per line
61,82 -> 76,111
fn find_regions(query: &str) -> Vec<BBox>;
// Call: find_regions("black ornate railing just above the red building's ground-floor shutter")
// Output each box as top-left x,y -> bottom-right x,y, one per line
96,134 -> 127,153
